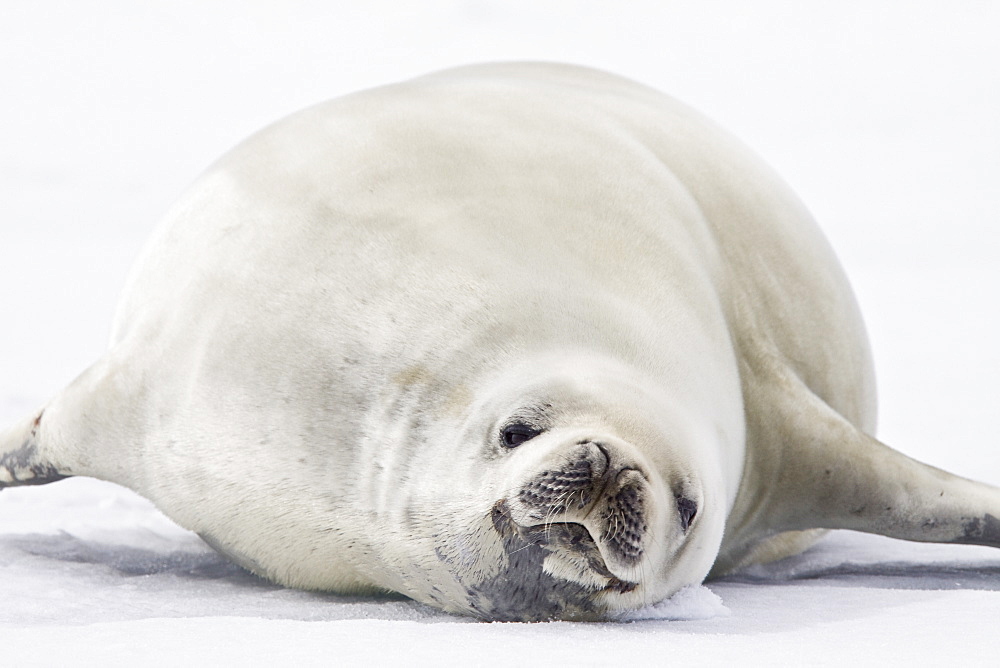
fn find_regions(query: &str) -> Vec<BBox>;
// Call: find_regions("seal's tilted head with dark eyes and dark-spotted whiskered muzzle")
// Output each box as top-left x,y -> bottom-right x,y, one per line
372,359 -> 726,621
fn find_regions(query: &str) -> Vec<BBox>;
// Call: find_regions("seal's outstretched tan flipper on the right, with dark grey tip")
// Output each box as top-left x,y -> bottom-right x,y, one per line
713,358 -> 1000,575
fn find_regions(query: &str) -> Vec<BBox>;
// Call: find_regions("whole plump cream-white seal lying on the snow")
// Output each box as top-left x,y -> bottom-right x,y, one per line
0,64 -> 1000,619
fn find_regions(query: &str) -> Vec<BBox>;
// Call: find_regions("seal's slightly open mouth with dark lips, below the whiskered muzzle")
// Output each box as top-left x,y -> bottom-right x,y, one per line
491,499 -> 639,594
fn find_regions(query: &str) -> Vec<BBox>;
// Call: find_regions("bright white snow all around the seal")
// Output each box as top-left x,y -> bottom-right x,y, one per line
0,0 -> 1000,665
